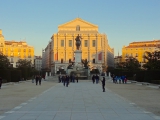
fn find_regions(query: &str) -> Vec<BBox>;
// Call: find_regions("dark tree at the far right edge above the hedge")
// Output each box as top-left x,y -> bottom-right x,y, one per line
143,51 -> 160,70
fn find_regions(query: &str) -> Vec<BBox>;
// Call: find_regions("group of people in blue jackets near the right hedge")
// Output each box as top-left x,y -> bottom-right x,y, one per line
112,74 -> 127,84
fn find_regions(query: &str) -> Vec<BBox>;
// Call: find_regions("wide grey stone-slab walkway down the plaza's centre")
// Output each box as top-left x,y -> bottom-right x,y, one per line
0,81 -> 159,120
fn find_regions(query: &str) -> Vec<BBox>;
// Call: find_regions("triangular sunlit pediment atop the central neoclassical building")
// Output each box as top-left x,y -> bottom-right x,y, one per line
58,18 -> 98,30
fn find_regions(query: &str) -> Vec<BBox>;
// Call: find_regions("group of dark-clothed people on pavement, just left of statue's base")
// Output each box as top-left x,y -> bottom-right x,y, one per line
58,74 -> 78,87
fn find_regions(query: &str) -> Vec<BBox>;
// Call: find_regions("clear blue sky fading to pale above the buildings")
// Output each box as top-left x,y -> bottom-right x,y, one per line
0,0 -> 160,55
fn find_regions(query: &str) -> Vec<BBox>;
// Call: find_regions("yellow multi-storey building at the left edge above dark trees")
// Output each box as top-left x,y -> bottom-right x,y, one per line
0,30 -> 34,67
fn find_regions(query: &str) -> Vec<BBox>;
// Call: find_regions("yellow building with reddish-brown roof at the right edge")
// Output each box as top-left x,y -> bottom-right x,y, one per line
122,40 -> 160,63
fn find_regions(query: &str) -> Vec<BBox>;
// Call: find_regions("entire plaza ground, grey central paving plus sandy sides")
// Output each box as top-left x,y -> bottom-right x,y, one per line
0,77 -> 160,120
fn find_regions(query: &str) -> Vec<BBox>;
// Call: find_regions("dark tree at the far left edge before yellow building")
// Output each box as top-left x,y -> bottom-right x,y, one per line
0,53 -> 10,69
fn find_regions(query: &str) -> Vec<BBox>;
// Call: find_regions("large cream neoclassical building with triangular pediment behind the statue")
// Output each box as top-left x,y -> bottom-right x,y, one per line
43,18 -> 114,74
